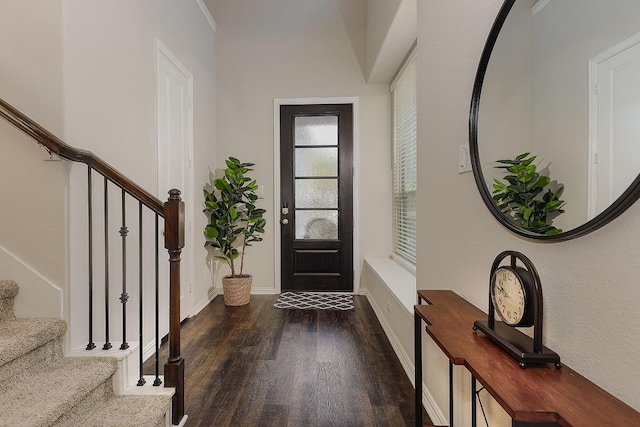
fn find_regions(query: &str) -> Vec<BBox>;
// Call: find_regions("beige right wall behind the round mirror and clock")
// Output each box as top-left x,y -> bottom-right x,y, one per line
417,0 -> 640,425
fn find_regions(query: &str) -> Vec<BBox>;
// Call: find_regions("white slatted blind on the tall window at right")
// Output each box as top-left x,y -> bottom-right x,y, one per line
391,55 -> 418,264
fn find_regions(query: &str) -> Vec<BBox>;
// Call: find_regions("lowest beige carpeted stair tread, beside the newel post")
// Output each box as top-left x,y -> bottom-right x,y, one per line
56,395 -> 171,427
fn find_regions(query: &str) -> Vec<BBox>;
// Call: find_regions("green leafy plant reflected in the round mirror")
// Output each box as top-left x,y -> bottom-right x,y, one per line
492,153 -> 564,235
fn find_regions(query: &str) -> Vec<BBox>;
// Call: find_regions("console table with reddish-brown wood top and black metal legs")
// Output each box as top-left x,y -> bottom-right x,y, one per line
414,290 -> 640,427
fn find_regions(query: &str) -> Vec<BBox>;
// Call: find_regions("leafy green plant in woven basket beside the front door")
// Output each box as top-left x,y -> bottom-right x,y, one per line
204,157 -> 266,306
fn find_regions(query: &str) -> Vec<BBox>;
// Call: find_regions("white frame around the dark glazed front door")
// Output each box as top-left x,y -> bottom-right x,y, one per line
273,96 -> 360,294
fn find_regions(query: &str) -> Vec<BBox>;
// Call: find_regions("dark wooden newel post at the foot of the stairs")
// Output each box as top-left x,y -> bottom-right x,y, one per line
164,189 -> 184,425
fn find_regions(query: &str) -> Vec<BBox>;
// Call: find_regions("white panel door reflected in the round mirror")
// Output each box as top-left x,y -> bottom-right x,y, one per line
589,37 -> 640,218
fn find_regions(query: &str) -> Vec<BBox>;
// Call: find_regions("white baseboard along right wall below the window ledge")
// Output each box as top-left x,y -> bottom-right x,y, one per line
360,289 -> 448,425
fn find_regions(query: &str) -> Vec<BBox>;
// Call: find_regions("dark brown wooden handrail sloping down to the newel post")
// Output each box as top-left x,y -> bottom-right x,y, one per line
0,99 -> 164,217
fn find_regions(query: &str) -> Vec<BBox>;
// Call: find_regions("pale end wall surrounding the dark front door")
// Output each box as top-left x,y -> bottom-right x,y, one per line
207,0 -> 391,292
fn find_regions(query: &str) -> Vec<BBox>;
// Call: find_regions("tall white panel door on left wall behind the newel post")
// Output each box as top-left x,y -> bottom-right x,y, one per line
156,40 -> 194,320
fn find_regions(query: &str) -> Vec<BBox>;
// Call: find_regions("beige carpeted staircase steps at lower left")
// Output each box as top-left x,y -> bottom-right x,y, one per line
0,280 -> 171,427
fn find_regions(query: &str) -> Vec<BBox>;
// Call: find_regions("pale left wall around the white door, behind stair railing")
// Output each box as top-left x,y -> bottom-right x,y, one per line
64,0 -> 216,352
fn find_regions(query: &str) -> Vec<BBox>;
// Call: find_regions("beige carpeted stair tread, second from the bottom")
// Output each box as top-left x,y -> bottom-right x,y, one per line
0,357 -> 117,427
